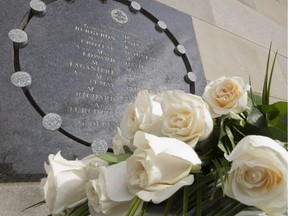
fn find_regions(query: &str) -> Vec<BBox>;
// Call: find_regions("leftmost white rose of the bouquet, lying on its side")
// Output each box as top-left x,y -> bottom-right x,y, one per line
41,152 -> 106,214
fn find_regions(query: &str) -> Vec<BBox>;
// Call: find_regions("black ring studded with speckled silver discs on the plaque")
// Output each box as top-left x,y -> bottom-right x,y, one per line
8,0 -> 196,154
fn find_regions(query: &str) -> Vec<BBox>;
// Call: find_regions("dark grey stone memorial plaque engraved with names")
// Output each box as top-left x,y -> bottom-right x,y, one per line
0,0 -> 206,182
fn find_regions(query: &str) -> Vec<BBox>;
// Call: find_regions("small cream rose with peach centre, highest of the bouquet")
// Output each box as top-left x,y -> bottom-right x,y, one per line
202,76 -> 249,118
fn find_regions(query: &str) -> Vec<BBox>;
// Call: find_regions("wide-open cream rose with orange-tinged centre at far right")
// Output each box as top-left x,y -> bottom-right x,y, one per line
225,135 -> 288,215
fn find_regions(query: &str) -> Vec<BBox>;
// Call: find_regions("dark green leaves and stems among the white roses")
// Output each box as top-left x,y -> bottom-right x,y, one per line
31,45 -> 287,216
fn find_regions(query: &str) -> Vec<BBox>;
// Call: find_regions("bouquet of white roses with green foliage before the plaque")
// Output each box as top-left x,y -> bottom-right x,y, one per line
41,46 -> 288,216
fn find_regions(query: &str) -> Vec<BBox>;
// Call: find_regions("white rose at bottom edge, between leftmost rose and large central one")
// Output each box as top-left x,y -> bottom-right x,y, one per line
86,162 -> 134,216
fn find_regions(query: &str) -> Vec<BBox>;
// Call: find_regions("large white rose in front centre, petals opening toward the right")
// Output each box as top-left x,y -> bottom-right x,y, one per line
126,131 -> 201,204
